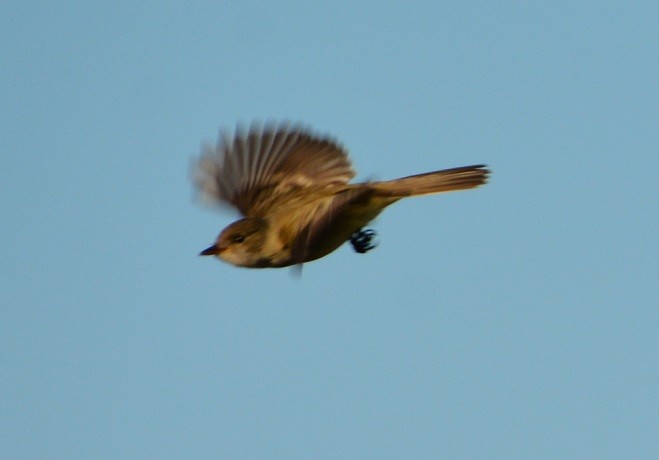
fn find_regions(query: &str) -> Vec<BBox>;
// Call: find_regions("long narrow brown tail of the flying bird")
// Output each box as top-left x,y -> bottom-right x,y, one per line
371,165 -> 490,198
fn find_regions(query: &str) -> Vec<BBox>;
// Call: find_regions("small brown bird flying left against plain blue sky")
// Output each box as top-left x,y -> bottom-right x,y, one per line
192,122 -> 490,268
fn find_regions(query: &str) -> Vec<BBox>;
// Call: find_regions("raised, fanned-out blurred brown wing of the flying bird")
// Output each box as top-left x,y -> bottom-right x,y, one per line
195,124 -> 355,217
